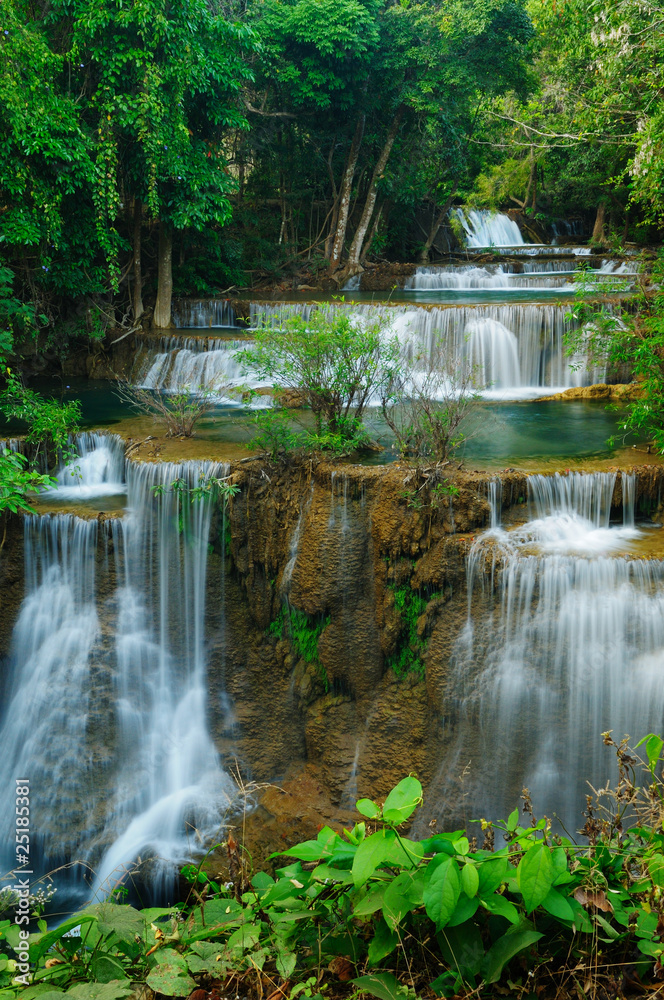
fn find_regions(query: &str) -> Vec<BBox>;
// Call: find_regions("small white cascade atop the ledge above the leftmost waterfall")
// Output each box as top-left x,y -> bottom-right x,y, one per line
44,431 -> 127,500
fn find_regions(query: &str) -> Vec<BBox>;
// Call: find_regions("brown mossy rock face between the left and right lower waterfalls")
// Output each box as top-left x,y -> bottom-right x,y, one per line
210,461 -> 492,804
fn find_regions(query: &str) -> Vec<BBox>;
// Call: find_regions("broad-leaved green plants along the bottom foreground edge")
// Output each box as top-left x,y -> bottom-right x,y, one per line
10,733 -> 664,1000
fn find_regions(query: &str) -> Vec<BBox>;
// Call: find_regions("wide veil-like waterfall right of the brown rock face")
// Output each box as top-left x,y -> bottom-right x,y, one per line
426,473 -> 664,831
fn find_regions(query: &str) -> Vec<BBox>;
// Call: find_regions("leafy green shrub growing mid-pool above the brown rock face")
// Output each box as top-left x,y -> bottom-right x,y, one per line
236,309 -> 402,453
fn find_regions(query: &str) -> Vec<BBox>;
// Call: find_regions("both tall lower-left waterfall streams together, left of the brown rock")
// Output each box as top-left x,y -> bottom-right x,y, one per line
0,450 -> 235,896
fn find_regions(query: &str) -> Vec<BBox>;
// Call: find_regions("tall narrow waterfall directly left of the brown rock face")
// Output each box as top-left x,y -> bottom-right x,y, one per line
94,462 -> 234,895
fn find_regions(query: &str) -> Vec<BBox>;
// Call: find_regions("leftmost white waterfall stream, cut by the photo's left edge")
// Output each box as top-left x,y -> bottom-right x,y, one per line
0,514 -> 101,884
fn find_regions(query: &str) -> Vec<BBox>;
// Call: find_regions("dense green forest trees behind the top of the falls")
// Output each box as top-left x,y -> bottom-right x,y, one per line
0,0 -> 664,351
